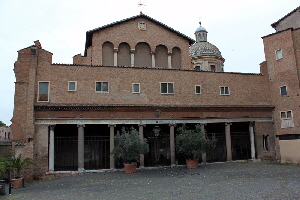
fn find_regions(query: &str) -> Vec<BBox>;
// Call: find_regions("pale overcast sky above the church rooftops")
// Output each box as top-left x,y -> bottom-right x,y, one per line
0,0 -> 299,125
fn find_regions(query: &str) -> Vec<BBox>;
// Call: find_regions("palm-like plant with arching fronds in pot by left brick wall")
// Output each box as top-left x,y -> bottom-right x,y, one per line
9,154 -> 37,188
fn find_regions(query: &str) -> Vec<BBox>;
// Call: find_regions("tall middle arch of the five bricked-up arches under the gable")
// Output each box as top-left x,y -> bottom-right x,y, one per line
134,42 -> 152,67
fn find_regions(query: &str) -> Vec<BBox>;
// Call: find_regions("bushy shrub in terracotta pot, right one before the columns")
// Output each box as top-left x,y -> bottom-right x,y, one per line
175,124 -> 217,168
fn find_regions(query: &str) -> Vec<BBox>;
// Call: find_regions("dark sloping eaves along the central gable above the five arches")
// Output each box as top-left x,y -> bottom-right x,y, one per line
84,12 -> 195,56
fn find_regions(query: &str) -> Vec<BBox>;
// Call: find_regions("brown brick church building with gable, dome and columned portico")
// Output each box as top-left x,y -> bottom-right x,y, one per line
11,8 -> 300,180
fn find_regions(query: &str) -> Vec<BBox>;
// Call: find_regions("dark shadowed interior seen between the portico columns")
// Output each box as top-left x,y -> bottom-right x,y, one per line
54,122 -> 251,171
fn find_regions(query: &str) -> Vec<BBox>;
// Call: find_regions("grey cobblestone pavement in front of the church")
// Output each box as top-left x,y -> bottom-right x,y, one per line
0,162 -> 300,200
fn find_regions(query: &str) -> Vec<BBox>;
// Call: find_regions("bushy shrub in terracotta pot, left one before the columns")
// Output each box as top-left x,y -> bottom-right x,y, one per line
112,127 -> 149,173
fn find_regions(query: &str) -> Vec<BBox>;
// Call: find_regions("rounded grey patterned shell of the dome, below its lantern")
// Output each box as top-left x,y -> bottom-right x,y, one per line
190,42 -> 224,60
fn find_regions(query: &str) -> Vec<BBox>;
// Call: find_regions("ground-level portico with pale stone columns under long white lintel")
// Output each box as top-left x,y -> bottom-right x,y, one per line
35,118 -> 271,172
